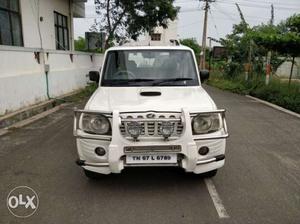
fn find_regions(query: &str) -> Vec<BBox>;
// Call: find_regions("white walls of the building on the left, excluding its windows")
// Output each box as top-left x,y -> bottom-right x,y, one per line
0,0 -> 102,116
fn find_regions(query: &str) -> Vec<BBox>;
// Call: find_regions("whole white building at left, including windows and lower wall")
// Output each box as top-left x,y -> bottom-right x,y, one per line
0,0 -> 102,115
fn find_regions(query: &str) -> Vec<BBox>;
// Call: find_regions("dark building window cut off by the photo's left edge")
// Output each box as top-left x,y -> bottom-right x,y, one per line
0,0 -> 23,46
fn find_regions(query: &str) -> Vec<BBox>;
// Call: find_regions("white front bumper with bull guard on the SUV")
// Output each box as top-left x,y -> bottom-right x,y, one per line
74,109 -> 228,174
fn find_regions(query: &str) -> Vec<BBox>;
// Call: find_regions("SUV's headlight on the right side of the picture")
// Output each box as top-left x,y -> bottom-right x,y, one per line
192,114 -> 220,135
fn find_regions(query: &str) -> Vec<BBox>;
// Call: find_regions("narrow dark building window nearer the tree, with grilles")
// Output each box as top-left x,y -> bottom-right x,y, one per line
54,12 -> 69,50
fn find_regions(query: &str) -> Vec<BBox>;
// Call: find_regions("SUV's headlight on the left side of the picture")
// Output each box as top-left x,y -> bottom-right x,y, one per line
82,114 -> 110,135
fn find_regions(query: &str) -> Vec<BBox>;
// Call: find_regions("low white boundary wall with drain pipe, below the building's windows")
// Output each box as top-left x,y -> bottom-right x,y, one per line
0,46 -> 103,115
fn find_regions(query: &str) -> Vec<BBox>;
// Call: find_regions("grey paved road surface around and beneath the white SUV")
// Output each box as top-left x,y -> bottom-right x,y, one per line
0,87 -> 300,224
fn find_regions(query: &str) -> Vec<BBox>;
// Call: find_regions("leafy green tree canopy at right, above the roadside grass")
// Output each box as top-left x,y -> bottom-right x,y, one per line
221,12 -> 300,78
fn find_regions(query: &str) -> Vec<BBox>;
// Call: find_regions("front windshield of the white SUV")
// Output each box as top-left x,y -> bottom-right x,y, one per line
101,50 -> 199,86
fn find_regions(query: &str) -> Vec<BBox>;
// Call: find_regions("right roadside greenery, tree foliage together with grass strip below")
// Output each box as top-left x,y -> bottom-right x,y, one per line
208,11 -> 300,113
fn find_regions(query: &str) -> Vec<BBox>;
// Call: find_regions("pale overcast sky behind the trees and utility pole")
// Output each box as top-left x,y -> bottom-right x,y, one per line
74,0 -> 300,45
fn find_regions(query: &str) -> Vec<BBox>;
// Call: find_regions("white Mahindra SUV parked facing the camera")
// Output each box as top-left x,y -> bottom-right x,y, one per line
74,46 -> 228,177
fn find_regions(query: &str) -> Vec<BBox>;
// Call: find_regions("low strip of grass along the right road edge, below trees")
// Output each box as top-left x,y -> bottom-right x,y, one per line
208,74 -> 300,113
